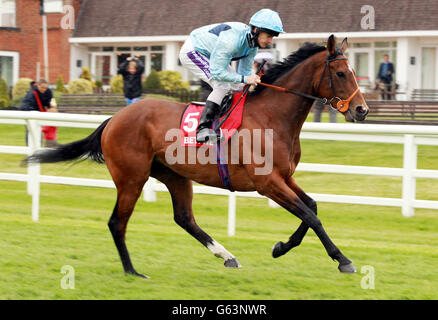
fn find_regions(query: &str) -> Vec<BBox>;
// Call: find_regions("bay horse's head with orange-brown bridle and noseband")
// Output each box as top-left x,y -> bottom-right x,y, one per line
314,35 -> 369,122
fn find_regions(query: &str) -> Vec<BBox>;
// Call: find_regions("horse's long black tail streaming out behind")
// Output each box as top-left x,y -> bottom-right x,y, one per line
23,119 -> 110,164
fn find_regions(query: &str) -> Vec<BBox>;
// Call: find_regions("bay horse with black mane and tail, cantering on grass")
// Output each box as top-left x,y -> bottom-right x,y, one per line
24,35 -> 369,278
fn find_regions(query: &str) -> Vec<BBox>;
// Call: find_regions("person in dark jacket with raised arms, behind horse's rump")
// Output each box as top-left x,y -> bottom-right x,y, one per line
117,57 -> 144,105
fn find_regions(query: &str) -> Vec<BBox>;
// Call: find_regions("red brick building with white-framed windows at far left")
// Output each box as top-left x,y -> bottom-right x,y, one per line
0,0 -> 81,86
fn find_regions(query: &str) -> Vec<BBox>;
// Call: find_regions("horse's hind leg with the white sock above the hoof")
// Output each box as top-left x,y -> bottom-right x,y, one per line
151,162 -> 241,268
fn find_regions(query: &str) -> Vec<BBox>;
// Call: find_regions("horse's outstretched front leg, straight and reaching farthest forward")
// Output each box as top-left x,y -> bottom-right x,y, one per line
257,175 -> 356,273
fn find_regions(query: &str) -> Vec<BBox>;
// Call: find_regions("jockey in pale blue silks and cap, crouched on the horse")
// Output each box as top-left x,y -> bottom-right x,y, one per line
179,9 -> 284,142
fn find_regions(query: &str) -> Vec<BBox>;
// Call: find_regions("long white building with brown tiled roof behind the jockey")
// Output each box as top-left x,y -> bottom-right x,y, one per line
0,0 -> 438,93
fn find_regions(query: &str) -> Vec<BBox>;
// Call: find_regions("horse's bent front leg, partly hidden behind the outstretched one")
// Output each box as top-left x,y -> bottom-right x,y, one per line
272,177 -> 317,258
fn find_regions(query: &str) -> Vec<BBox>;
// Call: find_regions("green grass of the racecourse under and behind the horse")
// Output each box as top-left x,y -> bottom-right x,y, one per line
0,113 -> 438,300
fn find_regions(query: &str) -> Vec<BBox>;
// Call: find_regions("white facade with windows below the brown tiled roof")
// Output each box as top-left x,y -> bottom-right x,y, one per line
70,30 -> 438,94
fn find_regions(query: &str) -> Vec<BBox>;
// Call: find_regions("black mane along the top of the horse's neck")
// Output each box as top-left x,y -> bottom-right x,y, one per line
252,42 -> 326,95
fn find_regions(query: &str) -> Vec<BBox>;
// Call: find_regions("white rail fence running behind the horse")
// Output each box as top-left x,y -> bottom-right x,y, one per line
0,111 -> 438,236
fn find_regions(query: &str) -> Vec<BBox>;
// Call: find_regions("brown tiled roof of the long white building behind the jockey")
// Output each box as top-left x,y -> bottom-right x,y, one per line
73,0 -> 438,37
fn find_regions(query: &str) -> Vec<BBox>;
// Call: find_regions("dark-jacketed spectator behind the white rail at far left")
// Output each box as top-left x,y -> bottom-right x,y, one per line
20,79 -> 58,148
